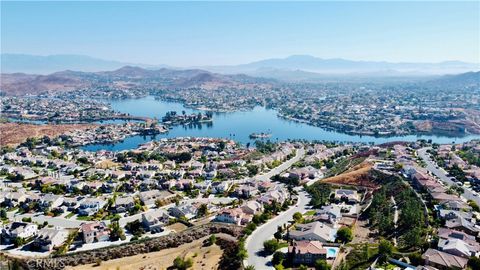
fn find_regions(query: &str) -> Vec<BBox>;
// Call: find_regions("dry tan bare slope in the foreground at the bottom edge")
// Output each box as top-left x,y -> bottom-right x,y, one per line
66,237 -> 222,270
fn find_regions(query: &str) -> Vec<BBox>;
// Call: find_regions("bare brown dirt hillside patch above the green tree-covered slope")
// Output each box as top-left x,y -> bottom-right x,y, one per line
322,162 -> 377,188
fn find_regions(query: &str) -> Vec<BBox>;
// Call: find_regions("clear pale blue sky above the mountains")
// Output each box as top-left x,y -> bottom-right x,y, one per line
1,1 -> 480,66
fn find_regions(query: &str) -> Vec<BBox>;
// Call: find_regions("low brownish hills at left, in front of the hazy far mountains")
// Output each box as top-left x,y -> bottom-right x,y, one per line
0,66 -> 274,96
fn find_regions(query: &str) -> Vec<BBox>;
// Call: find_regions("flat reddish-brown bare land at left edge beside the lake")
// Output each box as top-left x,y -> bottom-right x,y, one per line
0,123 -> 96,146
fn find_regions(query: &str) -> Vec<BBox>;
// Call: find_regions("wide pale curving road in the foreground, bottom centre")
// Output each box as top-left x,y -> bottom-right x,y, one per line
245,191 -> 310,269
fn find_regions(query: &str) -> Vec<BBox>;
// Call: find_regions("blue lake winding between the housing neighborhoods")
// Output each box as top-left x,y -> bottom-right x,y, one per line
83,97 -> 480,151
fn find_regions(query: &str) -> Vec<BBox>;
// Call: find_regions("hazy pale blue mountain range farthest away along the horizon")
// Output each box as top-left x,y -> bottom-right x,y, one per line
0,54 -> 480,81
